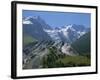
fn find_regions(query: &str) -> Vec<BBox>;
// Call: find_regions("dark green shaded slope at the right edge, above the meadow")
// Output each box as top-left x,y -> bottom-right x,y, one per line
71,32 -> 91,55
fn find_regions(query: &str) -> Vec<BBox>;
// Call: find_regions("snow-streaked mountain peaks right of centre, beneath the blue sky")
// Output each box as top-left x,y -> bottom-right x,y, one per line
44,24 -> 87,43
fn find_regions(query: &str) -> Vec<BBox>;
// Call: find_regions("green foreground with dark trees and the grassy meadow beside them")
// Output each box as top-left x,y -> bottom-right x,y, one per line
41,47 -> 91,68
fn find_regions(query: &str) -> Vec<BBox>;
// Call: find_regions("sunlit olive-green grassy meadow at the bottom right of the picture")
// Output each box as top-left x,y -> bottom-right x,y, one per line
56,56 -> 90,67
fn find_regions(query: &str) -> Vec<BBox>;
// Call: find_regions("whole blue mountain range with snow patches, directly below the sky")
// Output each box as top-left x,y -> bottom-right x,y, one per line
23,16 -> 90,43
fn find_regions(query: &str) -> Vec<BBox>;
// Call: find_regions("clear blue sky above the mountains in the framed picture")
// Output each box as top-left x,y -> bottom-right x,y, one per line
22,10 -> 91,27
